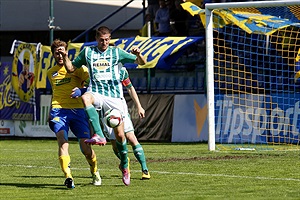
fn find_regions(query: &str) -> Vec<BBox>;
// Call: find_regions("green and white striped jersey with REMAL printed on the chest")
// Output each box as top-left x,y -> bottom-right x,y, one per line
72,46 -> 136,98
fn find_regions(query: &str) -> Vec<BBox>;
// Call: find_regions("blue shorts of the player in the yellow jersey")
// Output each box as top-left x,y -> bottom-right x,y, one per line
49,108 -> 90,139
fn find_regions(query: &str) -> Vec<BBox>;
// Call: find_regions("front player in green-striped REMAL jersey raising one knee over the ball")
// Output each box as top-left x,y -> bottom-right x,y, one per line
60,26 -> 146,185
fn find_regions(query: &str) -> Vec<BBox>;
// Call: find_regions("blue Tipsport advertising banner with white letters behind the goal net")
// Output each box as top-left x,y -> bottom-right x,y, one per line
215,93 -> 300,144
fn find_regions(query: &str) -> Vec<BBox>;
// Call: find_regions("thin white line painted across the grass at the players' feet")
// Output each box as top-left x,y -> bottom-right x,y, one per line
0,164 -> 300,182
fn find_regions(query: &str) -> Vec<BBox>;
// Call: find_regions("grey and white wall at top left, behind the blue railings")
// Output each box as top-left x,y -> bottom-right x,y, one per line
0,0 -> 143,31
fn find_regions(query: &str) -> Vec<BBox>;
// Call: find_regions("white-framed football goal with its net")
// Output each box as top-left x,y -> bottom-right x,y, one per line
202,0 -> 300,151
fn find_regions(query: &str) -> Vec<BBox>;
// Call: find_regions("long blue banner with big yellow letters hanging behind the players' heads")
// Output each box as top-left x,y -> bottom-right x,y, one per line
37,36 -> 204,88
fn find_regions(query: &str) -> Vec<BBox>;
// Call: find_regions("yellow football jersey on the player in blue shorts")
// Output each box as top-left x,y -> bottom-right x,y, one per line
47,65 -> 89,108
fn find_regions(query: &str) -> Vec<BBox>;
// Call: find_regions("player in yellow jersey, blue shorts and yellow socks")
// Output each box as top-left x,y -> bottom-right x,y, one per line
47,39 -> 101,188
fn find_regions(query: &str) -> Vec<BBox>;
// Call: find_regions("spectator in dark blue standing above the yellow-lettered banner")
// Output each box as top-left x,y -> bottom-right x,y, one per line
155,0 -> 171,36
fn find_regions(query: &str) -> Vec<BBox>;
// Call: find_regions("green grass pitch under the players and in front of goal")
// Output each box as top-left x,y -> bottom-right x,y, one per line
0,140 -> 300,200
